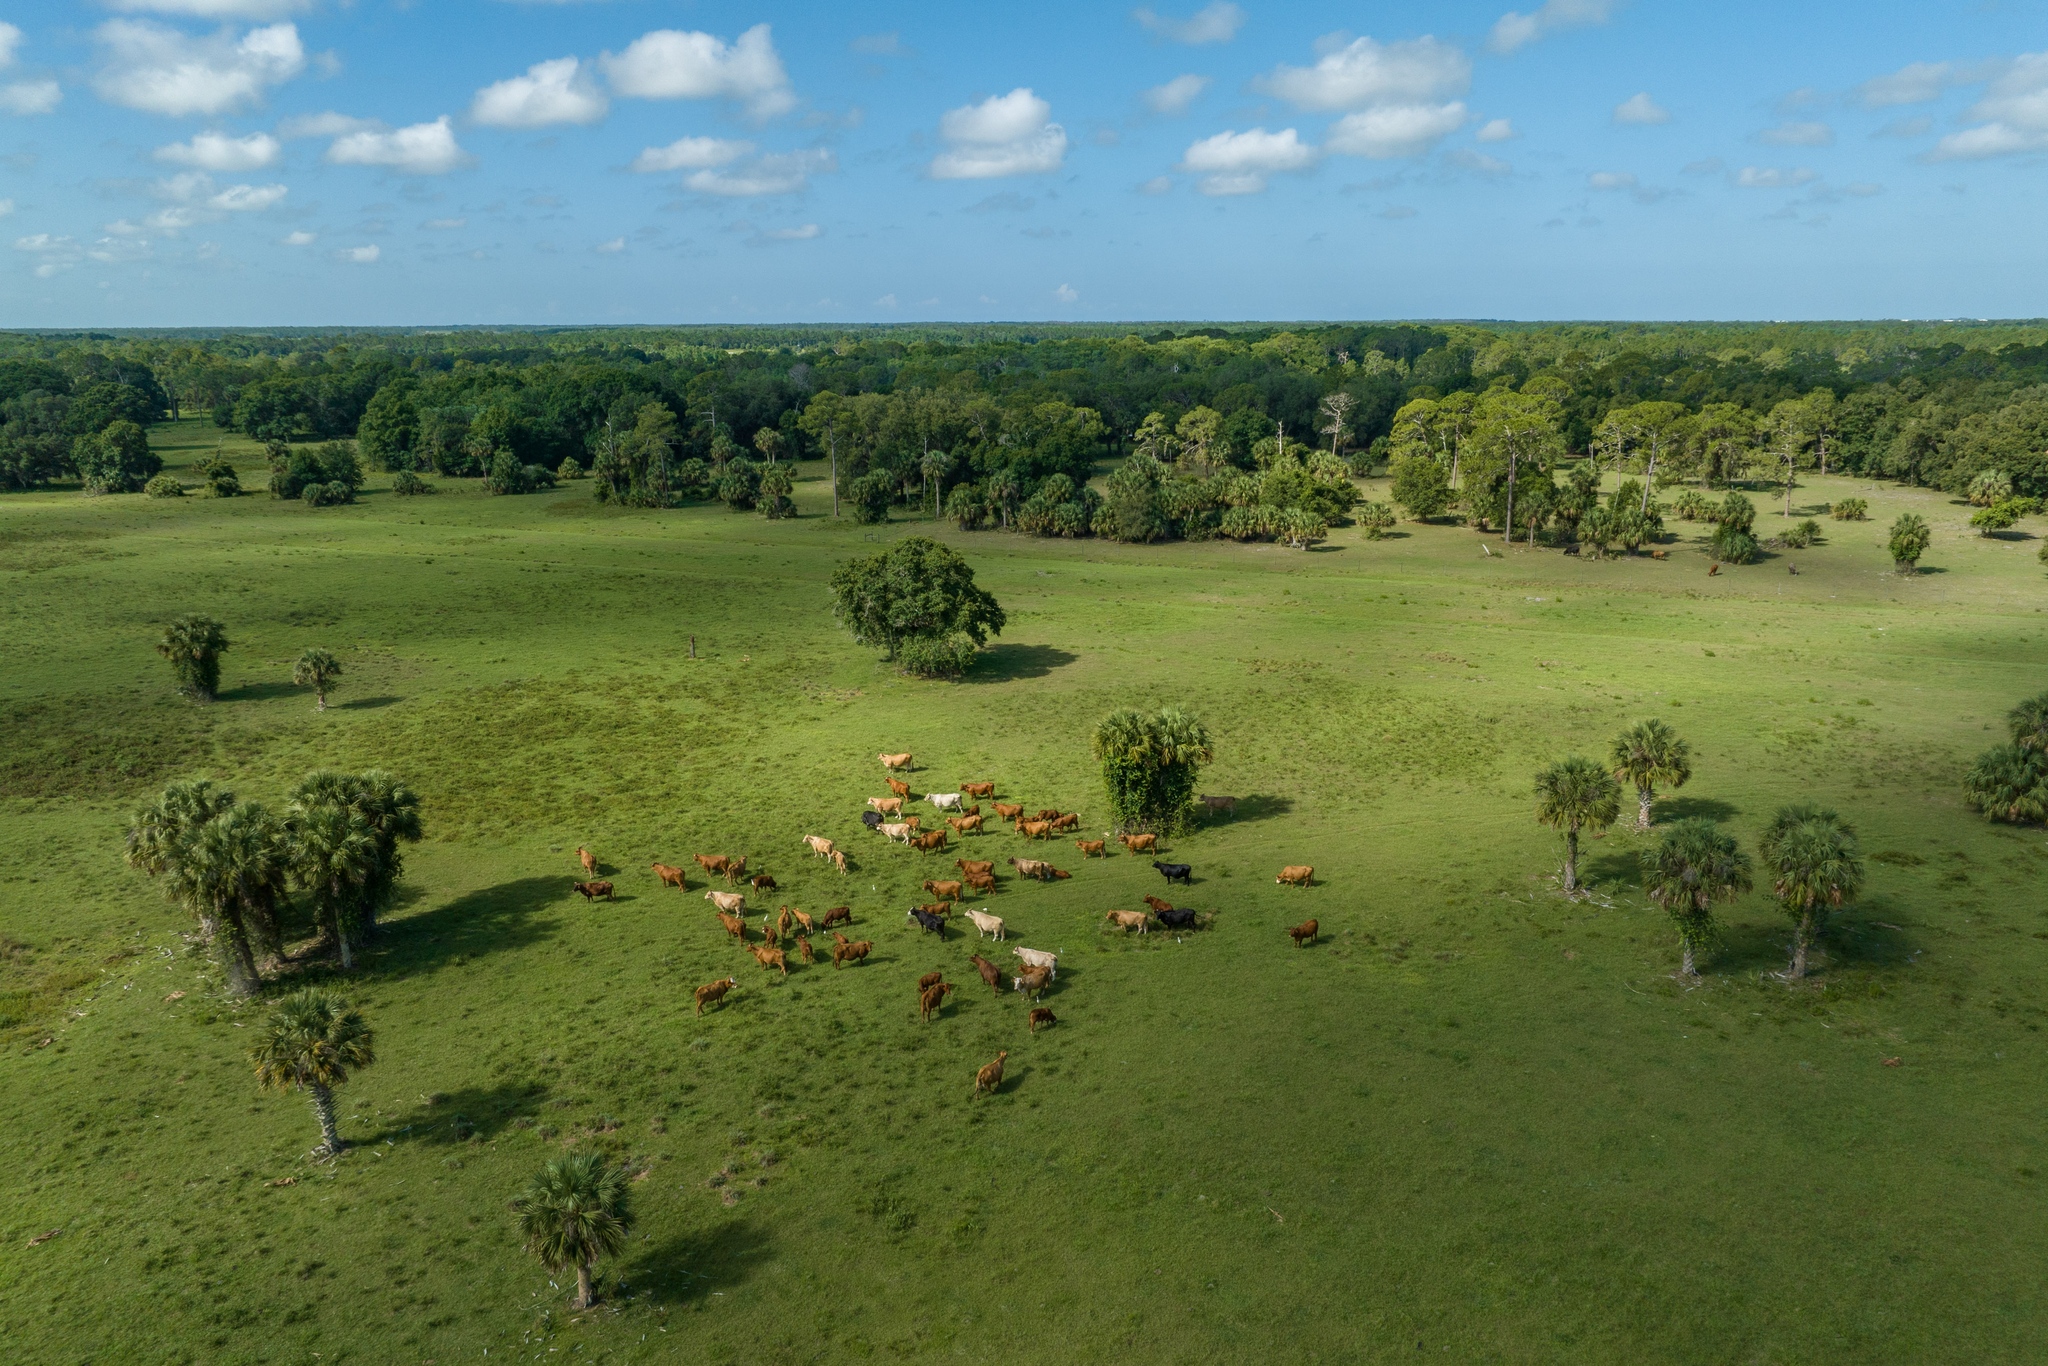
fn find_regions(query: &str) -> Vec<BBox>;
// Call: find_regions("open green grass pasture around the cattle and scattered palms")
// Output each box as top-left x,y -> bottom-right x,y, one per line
12,424 -> 2048,1362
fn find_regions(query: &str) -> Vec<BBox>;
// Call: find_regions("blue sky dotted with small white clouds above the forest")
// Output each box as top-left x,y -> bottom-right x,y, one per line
0,0 -> 2048,326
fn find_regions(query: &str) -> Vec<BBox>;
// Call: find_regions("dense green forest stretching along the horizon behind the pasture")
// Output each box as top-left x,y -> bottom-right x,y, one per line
0,324 -> 2048,541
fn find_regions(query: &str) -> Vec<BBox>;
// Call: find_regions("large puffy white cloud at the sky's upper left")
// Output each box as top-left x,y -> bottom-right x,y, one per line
92,18 -> 305,117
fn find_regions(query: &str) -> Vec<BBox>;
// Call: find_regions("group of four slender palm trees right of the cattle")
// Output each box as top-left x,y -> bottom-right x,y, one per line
1536,716 -> 1867,981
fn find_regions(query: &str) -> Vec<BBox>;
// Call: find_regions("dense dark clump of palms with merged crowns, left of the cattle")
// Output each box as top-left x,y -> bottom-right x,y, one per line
127,770 -> 420,997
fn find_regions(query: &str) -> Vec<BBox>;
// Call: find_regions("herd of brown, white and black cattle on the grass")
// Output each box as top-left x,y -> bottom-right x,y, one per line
571,754 -> 1319,1096
